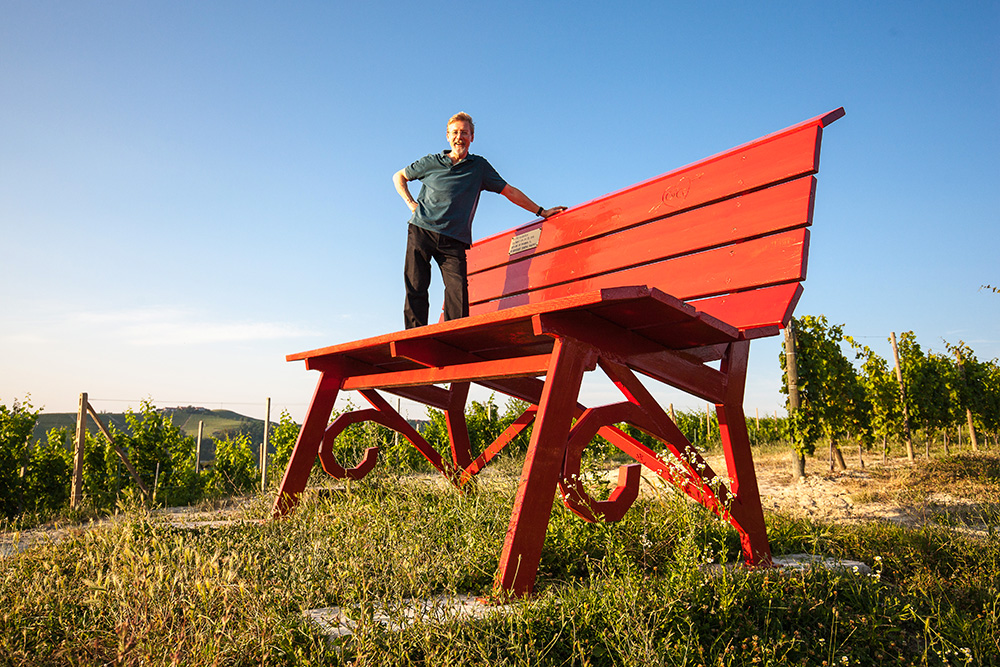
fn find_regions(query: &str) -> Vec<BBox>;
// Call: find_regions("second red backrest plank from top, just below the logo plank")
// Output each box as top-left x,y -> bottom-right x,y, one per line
469,176 -> 816,302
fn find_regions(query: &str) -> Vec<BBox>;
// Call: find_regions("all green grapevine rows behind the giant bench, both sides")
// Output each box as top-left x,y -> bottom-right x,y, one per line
0,316 -> 1000,525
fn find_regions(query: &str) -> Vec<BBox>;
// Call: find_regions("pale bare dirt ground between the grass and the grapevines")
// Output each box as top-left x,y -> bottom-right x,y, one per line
0,451 -> 1000,557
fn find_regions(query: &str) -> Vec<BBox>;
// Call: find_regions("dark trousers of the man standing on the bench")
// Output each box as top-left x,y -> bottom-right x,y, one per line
403,225 -> 469,329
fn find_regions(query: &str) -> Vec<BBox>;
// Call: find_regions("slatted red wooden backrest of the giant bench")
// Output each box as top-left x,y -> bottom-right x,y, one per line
468,109 -> 844,330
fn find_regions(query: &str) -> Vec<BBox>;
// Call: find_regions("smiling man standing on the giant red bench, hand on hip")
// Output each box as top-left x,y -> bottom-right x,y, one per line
392,113 -> 566,329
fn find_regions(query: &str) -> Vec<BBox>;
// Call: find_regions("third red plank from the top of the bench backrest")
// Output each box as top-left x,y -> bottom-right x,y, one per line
469,228 -> 809,314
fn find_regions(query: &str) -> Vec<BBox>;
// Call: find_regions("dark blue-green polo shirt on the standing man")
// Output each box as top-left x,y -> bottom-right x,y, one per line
403,151 -> 507,245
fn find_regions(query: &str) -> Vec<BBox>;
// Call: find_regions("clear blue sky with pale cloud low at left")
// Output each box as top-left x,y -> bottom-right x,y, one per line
0,0 -> 1000,419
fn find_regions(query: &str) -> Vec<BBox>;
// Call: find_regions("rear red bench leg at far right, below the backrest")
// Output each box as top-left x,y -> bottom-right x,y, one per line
715,341 -> 771,566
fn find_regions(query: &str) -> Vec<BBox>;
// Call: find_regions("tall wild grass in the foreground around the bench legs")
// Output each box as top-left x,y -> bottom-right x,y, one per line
0,460 -> 1000,667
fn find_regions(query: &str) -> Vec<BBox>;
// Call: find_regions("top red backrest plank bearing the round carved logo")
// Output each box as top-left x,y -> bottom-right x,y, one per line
468,126 -> 820,276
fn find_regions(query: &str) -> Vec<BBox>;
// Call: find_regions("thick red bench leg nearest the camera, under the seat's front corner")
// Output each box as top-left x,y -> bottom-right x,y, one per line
494,338 -> 597,597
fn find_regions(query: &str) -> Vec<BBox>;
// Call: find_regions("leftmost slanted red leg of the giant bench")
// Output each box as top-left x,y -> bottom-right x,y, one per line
271,372 -> 343,518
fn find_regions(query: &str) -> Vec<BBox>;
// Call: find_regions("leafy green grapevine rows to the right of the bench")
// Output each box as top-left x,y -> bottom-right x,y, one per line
780,316 -> 1000,474
